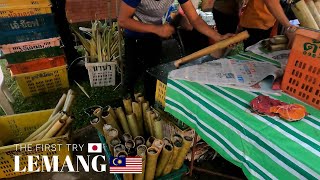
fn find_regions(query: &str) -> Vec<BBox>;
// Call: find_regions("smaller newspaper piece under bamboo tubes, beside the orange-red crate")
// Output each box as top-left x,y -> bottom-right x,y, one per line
246,40 -> 290,68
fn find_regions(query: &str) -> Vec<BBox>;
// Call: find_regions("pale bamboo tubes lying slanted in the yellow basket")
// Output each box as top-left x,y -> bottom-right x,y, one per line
23,89 -> 75,142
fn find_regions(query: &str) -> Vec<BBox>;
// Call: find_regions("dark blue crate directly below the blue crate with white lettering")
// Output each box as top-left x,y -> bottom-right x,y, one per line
0,27 -> 59,44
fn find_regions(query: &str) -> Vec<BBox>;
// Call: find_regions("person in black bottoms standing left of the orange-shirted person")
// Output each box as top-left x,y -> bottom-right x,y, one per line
201,0 -> 242,34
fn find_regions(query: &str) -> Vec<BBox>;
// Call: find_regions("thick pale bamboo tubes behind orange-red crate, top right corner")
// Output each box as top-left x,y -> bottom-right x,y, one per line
291,0 -> 320,30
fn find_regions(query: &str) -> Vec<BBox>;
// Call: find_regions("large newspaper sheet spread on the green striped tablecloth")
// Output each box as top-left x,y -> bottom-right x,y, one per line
169,59 -> 283,94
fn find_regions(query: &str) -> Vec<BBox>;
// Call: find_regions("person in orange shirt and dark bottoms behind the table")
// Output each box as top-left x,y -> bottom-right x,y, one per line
240,0 -> 296,48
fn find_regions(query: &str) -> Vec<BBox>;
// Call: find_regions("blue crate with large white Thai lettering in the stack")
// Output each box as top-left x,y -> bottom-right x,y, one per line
0,14 -> 55,32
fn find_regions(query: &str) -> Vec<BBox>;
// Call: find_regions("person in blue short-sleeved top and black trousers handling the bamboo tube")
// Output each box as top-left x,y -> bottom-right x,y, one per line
118,0 -> 233,104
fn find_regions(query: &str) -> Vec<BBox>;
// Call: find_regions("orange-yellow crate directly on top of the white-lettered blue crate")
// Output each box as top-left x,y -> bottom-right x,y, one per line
0,5 -> 52,18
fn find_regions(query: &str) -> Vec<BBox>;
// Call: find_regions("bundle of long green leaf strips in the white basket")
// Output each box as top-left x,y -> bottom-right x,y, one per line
73,20 -> 123,63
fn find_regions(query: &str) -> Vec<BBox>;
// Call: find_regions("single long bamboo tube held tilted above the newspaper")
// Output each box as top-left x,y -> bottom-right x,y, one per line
174,31 -> 249,68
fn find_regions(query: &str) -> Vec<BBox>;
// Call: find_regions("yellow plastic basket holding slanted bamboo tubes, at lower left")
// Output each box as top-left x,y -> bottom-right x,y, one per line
0,109 -> 71,179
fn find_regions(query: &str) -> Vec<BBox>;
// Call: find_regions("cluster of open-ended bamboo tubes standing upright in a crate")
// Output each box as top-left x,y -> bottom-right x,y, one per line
91,93 -> 193,180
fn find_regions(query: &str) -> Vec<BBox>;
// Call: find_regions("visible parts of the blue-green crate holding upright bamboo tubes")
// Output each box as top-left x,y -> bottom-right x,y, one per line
98,132 -> 188,180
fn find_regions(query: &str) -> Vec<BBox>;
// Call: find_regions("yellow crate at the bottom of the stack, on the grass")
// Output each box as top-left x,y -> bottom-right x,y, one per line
11,66 -> 69,97
